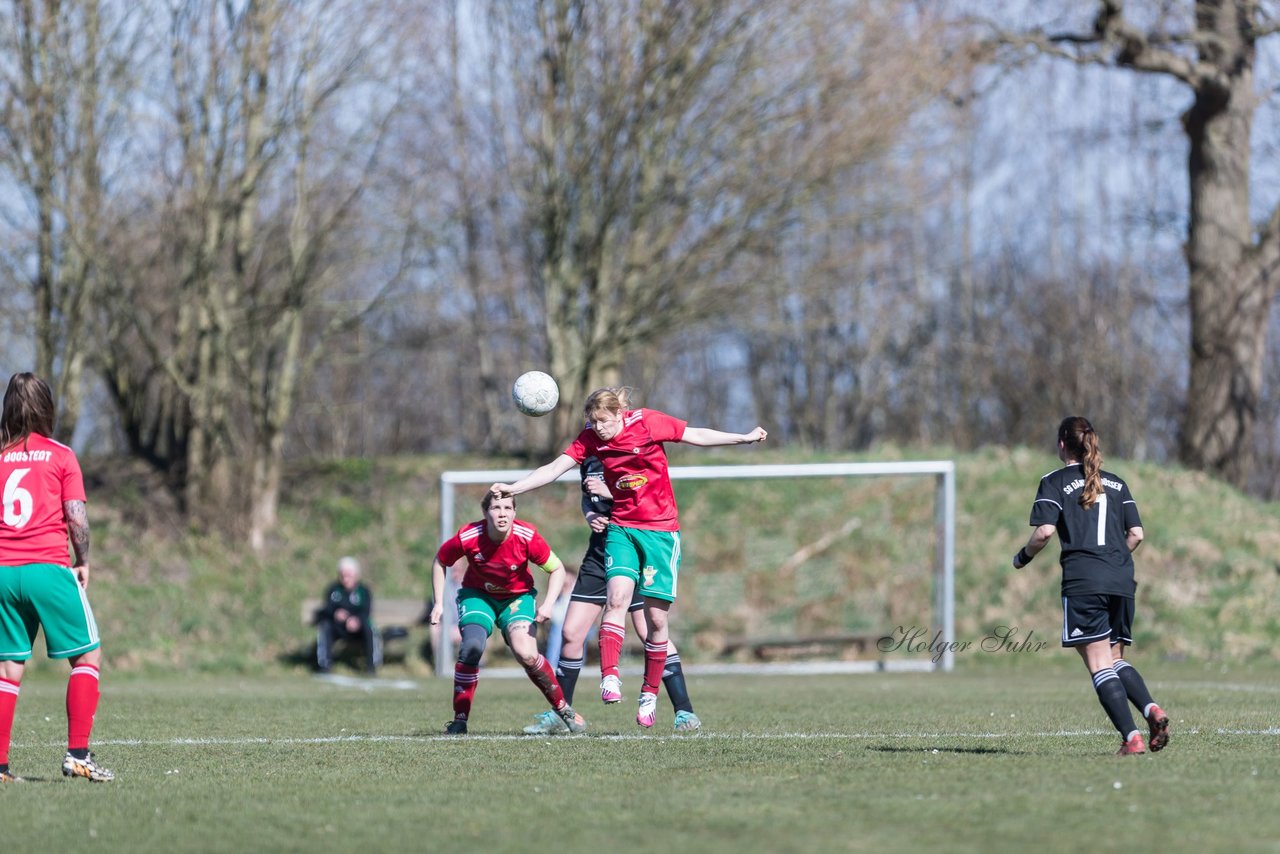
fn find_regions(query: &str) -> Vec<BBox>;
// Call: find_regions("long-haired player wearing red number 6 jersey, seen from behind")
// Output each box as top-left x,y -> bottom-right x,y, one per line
0,374 -> 115,782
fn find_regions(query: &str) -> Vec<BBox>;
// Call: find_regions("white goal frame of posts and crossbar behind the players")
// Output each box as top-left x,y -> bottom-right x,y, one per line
435,460 -> 955,676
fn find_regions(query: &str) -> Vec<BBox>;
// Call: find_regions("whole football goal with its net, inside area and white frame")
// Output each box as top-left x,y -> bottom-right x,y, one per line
435,461 -> 955,676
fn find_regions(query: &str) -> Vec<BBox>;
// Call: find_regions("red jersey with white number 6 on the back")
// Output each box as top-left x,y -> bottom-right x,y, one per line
0,433 -> 84,566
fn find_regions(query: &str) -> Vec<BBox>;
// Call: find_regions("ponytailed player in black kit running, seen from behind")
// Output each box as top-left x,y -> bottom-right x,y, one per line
1014,415 -> 1169,755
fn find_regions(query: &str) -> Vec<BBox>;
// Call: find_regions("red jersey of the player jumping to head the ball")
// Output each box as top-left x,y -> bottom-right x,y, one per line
564,410 -> 689,531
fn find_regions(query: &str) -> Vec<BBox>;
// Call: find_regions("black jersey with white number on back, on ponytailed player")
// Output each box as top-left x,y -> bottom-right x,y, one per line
1030,463 -> 1142,597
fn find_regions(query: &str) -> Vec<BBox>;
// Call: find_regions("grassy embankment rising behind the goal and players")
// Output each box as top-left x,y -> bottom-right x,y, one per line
60,448 -> 1280,672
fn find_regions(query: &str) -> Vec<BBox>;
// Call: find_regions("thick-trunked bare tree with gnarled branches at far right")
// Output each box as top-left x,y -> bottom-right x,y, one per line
1001,0 -> 1280,485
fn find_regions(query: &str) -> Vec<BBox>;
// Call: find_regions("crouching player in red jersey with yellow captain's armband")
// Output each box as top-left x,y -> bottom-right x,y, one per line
431,492 -> 586,735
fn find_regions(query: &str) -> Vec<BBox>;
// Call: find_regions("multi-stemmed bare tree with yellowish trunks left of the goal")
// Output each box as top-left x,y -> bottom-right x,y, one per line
105,0 -> 409,547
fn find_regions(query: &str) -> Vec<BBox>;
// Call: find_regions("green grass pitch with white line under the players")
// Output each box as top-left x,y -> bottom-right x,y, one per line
0,650 -> 1280,853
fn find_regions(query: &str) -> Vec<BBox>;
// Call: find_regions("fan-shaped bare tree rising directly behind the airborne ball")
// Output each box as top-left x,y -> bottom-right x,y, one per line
458,0 -> 901,434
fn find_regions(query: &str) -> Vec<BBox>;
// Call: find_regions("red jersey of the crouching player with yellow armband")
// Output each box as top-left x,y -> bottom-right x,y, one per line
435,519 -> 552,598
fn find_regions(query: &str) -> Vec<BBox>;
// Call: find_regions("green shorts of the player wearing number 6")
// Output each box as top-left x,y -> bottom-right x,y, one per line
0,563 -> 102,661
